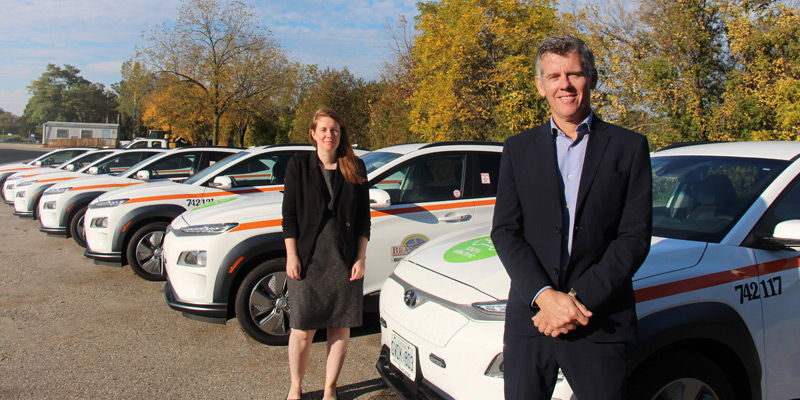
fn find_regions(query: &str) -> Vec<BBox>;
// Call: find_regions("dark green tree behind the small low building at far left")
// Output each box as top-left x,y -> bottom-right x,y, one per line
22,64 -> 117,126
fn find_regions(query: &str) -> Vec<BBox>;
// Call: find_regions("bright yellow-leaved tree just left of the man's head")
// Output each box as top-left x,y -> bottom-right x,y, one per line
410,0 -> 558,141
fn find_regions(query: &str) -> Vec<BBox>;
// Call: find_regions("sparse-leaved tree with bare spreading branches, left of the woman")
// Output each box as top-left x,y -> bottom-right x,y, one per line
138,0 -> 289,144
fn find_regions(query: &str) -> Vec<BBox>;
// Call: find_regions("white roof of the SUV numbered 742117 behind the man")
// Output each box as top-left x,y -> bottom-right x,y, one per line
652,141 -> 800,160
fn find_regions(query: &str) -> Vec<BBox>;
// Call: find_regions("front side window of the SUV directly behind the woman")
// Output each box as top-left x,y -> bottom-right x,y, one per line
372,153 -> 466,204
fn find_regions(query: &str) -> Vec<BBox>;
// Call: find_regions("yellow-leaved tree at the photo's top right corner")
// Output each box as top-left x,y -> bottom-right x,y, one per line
717,0 -> 800,140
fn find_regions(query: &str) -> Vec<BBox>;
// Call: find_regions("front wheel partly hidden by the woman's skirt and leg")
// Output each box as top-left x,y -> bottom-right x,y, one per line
236,258 -> 291,346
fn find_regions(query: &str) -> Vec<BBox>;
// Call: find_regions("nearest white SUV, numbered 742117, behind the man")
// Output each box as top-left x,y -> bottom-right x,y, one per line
377,142 -> 800,400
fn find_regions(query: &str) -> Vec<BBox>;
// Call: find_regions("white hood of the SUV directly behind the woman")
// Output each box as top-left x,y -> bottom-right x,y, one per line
180,192 -> 283,225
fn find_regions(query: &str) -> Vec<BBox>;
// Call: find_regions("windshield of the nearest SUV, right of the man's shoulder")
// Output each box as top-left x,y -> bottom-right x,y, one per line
651,156 -> 788,243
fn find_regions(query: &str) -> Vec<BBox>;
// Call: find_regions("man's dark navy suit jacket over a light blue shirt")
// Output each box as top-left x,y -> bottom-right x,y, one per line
492,116 -> 652,342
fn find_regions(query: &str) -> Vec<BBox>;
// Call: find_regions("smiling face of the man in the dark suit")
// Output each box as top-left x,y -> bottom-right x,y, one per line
536,53 -> 596,125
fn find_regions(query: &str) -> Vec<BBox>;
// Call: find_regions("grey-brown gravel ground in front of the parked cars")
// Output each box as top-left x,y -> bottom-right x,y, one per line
0,144 -> 398,400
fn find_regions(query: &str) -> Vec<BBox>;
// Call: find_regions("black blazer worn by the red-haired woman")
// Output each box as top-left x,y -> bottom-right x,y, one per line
283,152 -> 370,266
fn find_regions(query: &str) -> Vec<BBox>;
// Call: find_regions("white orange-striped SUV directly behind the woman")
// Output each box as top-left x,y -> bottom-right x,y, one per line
163,142 -> 502,344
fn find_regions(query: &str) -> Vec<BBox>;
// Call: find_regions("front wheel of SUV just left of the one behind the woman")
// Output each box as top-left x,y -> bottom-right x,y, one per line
126,222 -> 169,281
